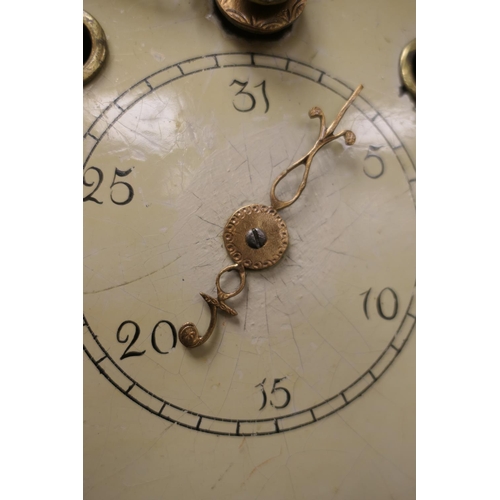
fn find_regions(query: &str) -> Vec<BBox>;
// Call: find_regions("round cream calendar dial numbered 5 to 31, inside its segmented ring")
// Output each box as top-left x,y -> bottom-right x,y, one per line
84,53 -> 415,435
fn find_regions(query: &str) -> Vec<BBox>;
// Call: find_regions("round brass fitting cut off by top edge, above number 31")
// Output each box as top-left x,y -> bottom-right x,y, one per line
217,0 -> 307,34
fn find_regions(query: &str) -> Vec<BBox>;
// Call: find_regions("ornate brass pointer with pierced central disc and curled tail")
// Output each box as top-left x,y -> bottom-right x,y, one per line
179,85 -> 363,347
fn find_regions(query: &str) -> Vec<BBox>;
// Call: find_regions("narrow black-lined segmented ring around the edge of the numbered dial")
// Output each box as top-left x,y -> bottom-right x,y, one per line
84,49 -> 414,436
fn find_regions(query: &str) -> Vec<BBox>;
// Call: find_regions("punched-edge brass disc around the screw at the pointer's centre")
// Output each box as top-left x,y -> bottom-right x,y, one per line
223,205 -> 288,269
